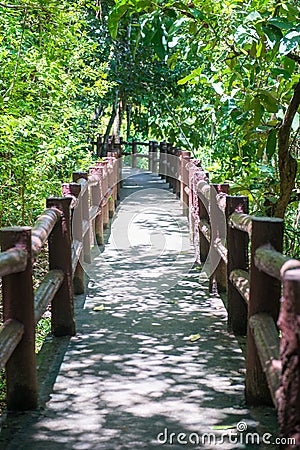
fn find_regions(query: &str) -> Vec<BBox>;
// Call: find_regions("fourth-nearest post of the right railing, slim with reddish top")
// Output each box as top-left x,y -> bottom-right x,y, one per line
209,183 -> 229,292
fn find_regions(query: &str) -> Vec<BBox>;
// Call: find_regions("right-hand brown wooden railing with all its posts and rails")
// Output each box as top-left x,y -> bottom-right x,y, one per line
176,156 -> 300,442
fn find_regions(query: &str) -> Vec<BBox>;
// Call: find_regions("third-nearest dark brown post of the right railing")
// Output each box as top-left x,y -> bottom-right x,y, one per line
225,195 -> 249,336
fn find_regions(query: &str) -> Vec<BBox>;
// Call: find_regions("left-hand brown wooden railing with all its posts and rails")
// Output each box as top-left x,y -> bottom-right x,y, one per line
0,154 -> 121,410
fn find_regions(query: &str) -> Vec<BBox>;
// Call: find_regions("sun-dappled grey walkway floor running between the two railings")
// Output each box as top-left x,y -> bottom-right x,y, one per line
0,170 -> 276,450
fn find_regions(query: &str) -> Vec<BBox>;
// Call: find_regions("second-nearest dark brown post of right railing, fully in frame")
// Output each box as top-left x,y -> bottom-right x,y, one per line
245,217 -> 283,405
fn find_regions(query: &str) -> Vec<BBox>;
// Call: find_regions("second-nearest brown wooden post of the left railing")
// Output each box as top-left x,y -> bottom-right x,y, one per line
47,197 -> 75,336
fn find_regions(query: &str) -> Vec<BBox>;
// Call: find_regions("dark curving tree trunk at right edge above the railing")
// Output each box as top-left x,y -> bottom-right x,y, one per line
275,82 -> 300,218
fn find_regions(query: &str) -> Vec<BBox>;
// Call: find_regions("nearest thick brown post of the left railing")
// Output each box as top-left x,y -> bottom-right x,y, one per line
0,227 -> 38,411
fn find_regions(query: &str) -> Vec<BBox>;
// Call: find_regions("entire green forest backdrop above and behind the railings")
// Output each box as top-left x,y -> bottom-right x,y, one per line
0,0 -> 300,256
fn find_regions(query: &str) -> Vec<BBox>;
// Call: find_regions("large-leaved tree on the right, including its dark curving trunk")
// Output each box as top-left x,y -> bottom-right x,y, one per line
110,0 -> 300,217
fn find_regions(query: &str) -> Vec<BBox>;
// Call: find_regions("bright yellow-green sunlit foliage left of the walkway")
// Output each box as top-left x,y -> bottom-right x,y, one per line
0,0 -> 108,225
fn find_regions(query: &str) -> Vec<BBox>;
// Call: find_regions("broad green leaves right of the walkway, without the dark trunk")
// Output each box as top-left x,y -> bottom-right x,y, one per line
109,0 -> 300,221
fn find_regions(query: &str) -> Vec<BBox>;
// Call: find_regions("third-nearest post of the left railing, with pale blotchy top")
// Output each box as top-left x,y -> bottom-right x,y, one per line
62,183 -> 85,294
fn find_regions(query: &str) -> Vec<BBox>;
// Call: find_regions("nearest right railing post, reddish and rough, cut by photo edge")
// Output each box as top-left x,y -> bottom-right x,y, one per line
278,269 -> 300,449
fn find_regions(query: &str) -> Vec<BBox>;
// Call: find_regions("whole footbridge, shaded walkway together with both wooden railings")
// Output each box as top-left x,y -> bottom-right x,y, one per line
0,142 -> 300,450
